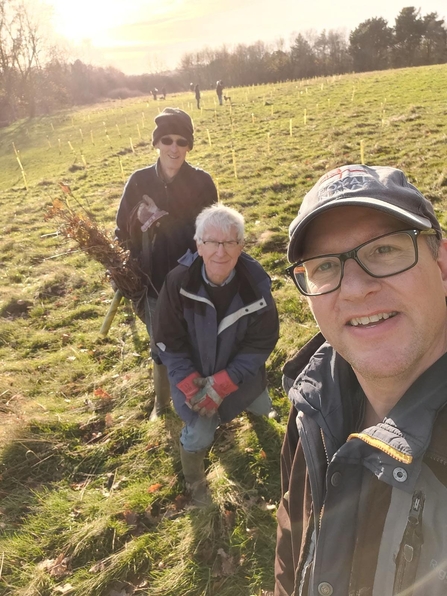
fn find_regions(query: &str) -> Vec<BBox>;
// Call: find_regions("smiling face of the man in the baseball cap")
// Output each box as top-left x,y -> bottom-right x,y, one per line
303,207 -> 447,382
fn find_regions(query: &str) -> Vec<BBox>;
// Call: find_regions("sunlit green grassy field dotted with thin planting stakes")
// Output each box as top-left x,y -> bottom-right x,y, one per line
0,66 -> 447,596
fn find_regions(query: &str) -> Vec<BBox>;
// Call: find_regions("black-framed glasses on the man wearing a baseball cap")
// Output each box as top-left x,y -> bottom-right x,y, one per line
286,229 -> 436,296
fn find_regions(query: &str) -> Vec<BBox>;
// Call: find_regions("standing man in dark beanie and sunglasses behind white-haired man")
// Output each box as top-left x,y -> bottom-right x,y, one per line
115,107 -> 217,419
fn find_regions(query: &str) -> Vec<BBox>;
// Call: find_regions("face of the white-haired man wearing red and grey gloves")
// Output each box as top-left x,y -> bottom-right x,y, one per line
197,226 -> 243,286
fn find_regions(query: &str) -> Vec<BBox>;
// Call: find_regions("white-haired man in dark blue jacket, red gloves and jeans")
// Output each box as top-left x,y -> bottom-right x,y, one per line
154,205 -> 279,505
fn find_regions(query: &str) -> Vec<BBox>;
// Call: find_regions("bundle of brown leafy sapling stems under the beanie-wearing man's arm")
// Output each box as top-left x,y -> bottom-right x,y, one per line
45,193 -> 146,300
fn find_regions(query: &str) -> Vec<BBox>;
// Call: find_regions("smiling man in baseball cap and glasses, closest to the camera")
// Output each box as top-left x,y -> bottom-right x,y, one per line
274,165 -> 447,596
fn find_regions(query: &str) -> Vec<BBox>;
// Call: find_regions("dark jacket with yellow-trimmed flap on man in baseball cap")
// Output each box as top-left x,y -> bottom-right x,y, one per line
274,335 -> 447,596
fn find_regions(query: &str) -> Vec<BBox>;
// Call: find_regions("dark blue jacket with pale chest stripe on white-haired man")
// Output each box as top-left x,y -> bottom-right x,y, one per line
154,253 -> 279,422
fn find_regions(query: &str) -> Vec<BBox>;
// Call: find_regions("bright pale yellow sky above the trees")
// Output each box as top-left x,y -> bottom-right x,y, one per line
47,0 -> 447,74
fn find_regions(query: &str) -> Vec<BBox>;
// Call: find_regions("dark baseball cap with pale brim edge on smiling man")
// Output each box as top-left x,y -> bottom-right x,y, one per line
287,164 -> 442,263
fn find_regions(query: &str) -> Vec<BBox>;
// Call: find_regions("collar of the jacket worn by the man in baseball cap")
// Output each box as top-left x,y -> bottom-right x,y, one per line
289,343 -> 447,489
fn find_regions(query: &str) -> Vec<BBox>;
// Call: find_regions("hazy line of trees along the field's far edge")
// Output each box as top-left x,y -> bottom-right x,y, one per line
0,0 -> 447,125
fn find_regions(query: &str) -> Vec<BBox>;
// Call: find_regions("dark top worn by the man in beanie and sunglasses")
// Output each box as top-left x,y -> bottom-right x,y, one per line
115,161 -> 217,297
